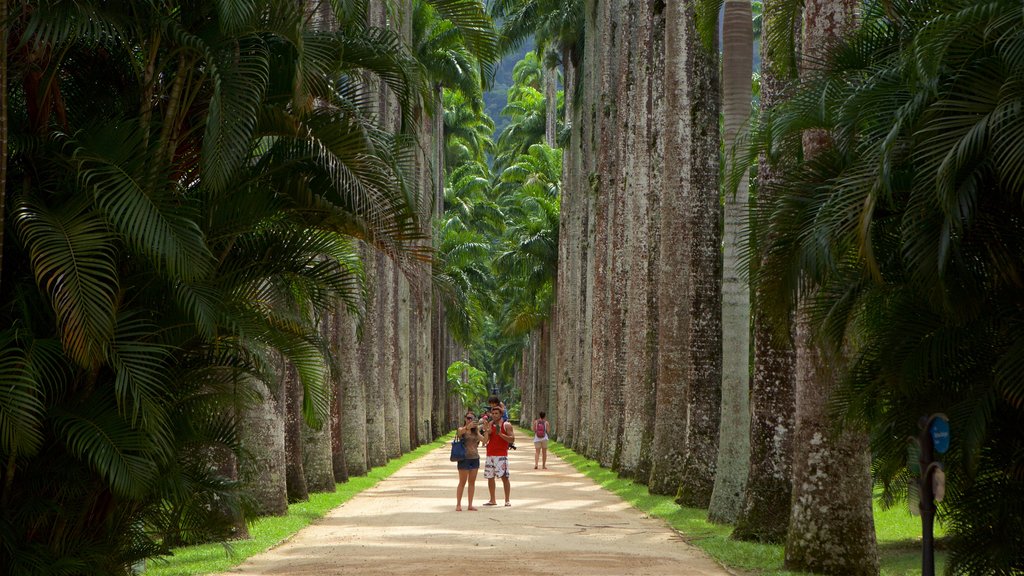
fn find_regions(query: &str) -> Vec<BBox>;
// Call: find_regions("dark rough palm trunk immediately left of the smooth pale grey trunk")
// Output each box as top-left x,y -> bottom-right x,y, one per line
660,2 -> 722,508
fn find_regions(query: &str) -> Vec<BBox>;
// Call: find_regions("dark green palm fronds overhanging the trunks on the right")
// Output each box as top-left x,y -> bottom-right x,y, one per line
757,0 -> 1024,574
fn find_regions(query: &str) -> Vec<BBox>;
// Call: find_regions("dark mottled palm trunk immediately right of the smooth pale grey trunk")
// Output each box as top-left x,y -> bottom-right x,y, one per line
732,0 -> 799,542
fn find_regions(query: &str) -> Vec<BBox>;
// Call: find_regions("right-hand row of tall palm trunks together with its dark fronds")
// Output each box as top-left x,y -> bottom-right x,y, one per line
495,0 -> 1024,574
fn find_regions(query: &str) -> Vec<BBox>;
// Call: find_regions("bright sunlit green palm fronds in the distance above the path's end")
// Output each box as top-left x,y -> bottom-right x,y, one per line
428,42 -> 561,413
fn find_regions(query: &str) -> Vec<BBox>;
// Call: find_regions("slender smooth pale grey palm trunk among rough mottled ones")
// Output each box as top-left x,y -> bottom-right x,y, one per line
708,0 -> 754,523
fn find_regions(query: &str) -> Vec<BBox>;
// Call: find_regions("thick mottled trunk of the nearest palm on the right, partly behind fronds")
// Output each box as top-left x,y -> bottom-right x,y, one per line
785,0 -> 879,576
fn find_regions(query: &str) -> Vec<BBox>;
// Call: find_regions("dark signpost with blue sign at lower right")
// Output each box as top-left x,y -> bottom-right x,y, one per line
910,413 -> 949,576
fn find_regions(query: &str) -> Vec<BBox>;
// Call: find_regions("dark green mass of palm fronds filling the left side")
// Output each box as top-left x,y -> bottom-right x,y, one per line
0,0 -> 425,576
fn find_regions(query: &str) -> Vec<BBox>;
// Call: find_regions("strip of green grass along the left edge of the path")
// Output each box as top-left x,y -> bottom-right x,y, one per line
145,439 -> 446,576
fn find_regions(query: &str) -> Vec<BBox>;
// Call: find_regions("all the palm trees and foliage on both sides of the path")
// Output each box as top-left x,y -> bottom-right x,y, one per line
0,0 -> 1024,575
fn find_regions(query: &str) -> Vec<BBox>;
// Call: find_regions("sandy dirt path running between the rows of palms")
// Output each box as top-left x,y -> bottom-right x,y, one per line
214,430 -> 729,576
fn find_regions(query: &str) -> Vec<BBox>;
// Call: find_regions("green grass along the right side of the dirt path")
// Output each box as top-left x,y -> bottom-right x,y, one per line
550,442 -> 945,576
